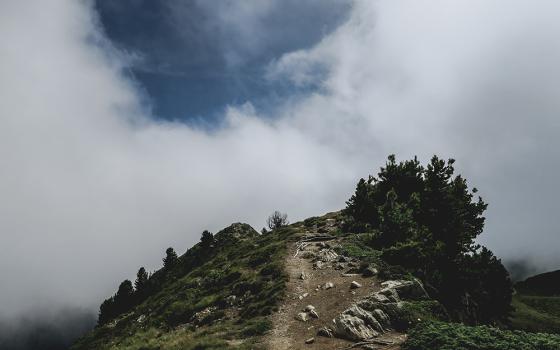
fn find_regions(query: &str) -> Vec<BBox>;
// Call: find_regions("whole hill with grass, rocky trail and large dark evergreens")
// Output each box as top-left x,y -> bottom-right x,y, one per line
73,157 -> 560,350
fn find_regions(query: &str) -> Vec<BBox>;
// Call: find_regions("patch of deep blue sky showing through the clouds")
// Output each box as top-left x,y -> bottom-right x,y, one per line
96,0 -> 350,119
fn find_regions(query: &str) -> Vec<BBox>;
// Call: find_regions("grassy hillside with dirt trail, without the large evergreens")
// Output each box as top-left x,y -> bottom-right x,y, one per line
73,213 -> 560,350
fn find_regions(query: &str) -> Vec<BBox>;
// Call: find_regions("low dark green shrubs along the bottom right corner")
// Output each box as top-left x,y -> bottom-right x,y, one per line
403,322 -> 560,350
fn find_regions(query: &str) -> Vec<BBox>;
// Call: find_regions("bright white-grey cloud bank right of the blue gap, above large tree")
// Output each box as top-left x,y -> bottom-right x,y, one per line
269,1 -> 560,274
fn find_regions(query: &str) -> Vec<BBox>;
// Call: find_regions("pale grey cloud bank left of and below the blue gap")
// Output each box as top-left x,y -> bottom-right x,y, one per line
0,1 -> 353,317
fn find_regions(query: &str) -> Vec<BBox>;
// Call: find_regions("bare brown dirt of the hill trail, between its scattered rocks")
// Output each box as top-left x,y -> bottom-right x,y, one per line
264,226 -> 405,350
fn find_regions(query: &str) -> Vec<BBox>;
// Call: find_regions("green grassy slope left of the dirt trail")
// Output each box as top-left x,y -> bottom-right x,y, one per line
72,224 -> 302,350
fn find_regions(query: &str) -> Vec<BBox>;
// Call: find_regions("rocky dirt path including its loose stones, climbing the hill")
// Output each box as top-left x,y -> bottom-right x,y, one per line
265,227 -> 405,350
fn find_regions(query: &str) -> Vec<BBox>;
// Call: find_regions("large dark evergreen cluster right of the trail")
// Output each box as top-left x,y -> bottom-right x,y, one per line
344,155 -> 512,323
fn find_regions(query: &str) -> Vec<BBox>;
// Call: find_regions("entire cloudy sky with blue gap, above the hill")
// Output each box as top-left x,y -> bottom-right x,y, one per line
0,0 -> 560,334
